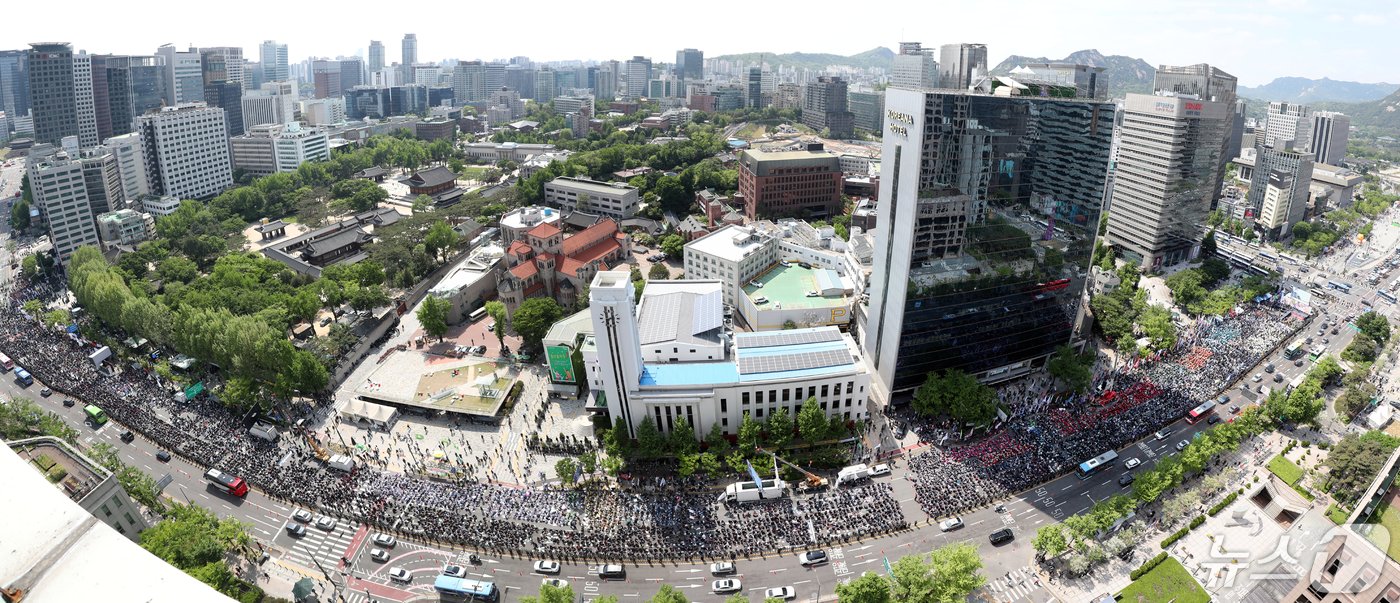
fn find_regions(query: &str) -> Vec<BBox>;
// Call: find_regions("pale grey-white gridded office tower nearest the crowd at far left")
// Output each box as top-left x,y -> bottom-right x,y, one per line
29,146 -> 98,266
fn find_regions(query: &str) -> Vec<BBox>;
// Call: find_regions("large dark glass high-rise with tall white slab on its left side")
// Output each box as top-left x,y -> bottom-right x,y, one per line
862,88 -> 1114,392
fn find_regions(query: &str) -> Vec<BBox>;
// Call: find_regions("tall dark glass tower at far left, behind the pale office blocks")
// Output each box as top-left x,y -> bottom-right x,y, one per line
28,42 -> 78,145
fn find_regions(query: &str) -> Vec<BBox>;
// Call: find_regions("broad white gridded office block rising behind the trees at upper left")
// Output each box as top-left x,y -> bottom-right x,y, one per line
140,102 -> 234,199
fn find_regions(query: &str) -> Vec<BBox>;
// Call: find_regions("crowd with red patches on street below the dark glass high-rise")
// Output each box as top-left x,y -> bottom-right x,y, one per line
906,305 -> 1298,518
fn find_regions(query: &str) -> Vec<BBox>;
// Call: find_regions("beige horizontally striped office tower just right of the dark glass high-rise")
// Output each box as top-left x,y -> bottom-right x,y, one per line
1107,92 -> 1233,271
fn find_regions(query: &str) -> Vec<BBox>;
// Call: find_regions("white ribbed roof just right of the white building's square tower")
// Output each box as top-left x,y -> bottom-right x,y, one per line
637,280 -> 724,346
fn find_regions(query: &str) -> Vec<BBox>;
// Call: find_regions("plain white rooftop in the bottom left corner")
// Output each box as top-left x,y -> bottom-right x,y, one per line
0,438 -> 231,603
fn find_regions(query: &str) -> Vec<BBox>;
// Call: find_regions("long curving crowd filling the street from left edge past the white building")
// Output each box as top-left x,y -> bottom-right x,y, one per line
0,285 -> 906,560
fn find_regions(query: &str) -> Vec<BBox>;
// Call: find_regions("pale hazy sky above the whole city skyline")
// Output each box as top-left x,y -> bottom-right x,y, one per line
13,0 -> 1400,85
